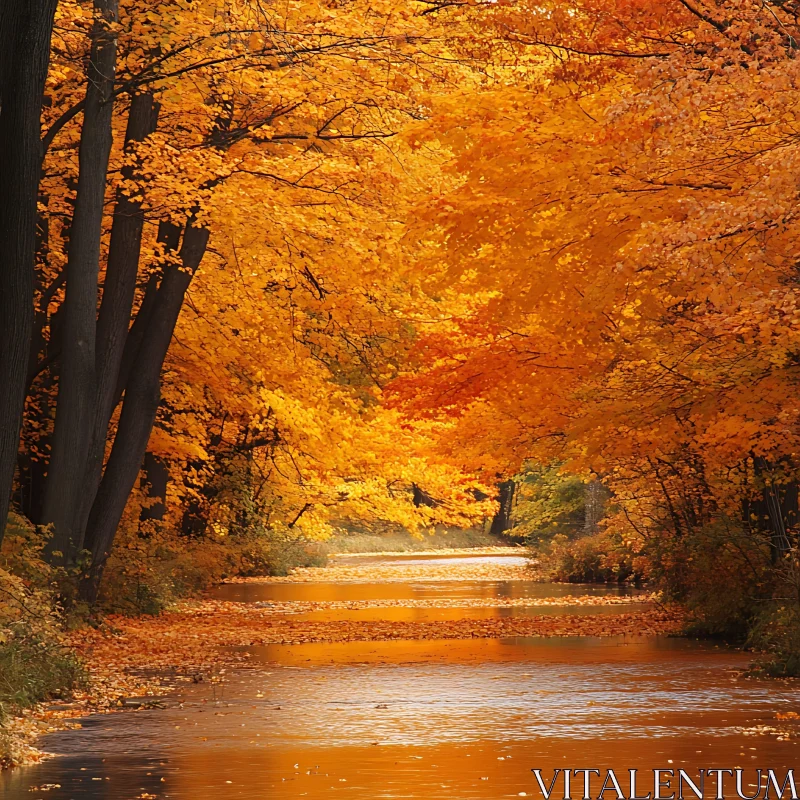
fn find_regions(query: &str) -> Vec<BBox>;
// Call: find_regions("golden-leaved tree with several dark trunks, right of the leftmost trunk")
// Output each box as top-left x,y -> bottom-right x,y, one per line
14,0 -> 494,601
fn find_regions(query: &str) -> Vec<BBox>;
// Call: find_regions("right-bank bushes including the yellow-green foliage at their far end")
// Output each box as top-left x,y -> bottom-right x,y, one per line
490,461 -> 800,677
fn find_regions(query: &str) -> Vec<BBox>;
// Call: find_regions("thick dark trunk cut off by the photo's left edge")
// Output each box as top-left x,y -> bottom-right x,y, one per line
0,0 -> 57,543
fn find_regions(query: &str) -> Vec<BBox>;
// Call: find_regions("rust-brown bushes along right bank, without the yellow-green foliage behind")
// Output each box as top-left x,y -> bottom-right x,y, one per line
528,488 -> 800,677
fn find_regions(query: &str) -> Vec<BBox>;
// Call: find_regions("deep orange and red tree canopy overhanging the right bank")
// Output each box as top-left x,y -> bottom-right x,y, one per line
396,0 -> 800,560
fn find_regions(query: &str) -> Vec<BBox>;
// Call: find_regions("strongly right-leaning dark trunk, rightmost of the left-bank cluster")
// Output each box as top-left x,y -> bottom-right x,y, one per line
81,220 -> 209,603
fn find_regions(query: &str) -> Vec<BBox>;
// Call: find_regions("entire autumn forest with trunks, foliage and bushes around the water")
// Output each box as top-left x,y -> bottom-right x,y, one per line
0,0 -> 800,780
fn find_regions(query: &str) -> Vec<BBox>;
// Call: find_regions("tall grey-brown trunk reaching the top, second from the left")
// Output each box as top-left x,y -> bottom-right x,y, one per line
43,0 -> 119,561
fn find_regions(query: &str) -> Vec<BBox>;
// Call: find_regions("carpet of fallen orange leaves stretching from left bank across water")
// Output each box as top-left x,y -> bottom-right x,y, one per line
6,608 -> 684,766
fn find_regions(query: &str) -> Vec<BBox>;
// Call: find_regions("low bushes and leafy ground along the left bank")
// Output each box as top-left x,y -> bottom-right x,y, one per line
0,515 -> 338,767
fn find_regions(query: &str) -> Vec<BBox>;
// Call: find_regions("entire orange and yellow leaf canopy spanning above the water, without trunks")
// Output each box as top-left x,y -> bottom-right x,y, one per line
37,0 -> 800,548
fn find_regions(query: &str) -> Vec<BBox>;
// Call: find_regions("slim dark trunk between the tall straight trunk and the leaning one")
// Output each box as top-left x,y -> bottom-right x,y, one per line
75,93 -> 159,545
